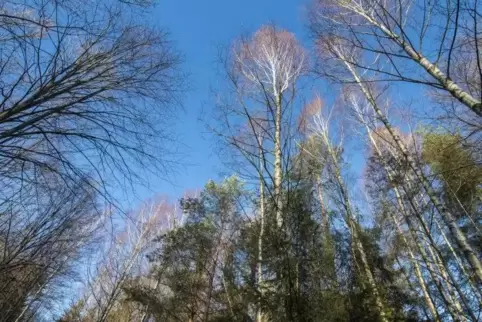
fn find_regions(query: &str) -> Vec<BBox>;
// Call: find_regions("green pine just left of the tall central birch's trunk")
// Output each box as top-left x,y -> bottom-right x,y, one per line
126,177 -> 249,321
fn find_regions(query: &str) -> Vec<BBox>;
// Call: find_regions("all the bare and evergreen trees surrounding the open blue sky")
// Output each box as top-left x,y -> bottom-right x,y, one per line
0,0 -> 482,322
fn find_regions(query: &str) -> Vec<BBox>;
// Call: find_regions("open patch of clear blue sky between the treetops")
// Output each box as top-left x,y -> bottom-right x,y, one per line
130,0 -> 310,198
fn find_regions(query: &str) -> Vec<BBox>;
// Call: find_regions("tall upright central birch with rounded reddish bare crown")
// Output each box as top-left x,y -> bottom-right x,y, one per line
232,26 -> 306,227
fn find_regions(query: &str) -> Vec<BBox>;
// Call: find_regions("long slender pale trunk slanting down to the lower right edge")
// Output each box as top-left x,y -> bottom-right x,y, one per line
339,53 -> 482,283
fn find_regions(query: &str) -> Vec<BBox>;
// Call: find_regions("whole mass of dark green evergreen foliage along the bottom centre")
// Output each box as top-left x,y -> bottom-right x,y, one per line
127,174 -> 418,322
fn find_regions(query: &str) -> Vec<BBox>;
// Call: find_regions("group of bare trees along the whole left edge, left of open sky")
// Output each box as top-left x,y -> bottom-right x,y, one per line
0,0 -> 182,321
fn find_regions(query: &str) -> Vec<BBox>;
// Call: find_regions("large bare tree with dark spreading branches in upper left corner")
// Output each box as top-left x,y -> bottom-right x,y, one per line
0,0 -> 181,209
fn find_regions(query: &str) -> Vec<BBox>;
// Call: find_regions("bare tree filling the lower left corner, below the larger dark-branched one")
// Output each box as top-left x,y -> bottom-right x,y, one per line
0,177 -> 104,321
